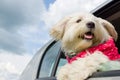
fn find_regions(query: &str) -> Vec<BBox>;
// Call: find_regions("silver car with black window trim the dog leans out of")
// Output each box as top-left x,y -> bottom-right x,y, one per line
20,0 -> 120,80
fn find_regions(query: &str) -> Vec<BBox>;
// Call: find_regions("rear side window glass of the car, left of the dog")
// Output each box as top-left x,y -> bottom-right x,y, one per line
39,42 -> 60,78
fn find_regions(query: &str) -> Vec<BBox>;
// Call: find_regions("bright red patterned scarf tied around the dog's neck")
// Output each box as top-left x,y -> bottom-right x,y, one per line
66,38 -> 120,63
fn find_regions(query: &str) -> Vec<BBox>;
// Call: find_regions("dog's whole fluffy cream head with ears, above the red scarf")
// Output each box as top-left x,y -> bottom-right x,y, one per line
50,14 -> 117,53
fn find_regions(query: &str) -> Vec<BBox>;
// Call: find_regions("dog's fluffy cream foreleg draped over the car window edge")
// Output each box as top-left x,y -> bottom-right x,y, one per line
57,52 -> 108,80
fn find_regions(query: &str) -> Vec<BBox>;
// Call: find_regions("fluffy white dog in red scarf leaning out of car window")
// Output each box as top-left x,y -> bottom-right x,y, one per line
50,13 -> 120,80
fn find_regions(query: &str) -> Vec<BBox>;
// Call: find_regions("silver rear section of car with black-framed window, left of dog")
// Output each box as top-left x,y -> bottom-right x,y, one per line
19,40 -> 61,80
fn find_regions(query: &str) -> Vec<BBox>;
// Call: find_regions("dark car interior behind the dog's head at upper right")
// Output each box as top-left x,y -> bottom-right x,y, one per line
93,0 -> 120,53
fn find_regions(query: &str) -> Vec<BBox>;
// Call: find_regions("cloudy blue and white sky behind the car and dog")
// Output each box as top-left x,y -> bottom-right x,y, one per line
0,0 -> 106,80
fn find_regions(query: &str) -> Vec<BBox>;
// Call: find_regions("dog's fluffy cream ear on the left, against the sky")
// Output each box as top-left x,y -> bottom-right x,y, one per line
50,17 -> 71,40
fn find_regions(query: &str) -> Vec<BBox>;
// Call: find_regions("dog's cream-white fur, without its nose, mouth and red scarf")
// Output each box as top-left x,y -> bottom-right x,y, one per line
50,14 -> 120,80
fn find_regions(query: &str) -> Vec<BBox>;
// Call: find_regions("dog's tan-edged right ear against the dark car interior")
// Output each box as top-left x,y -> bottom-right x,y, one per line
99,18 -> 118,41
